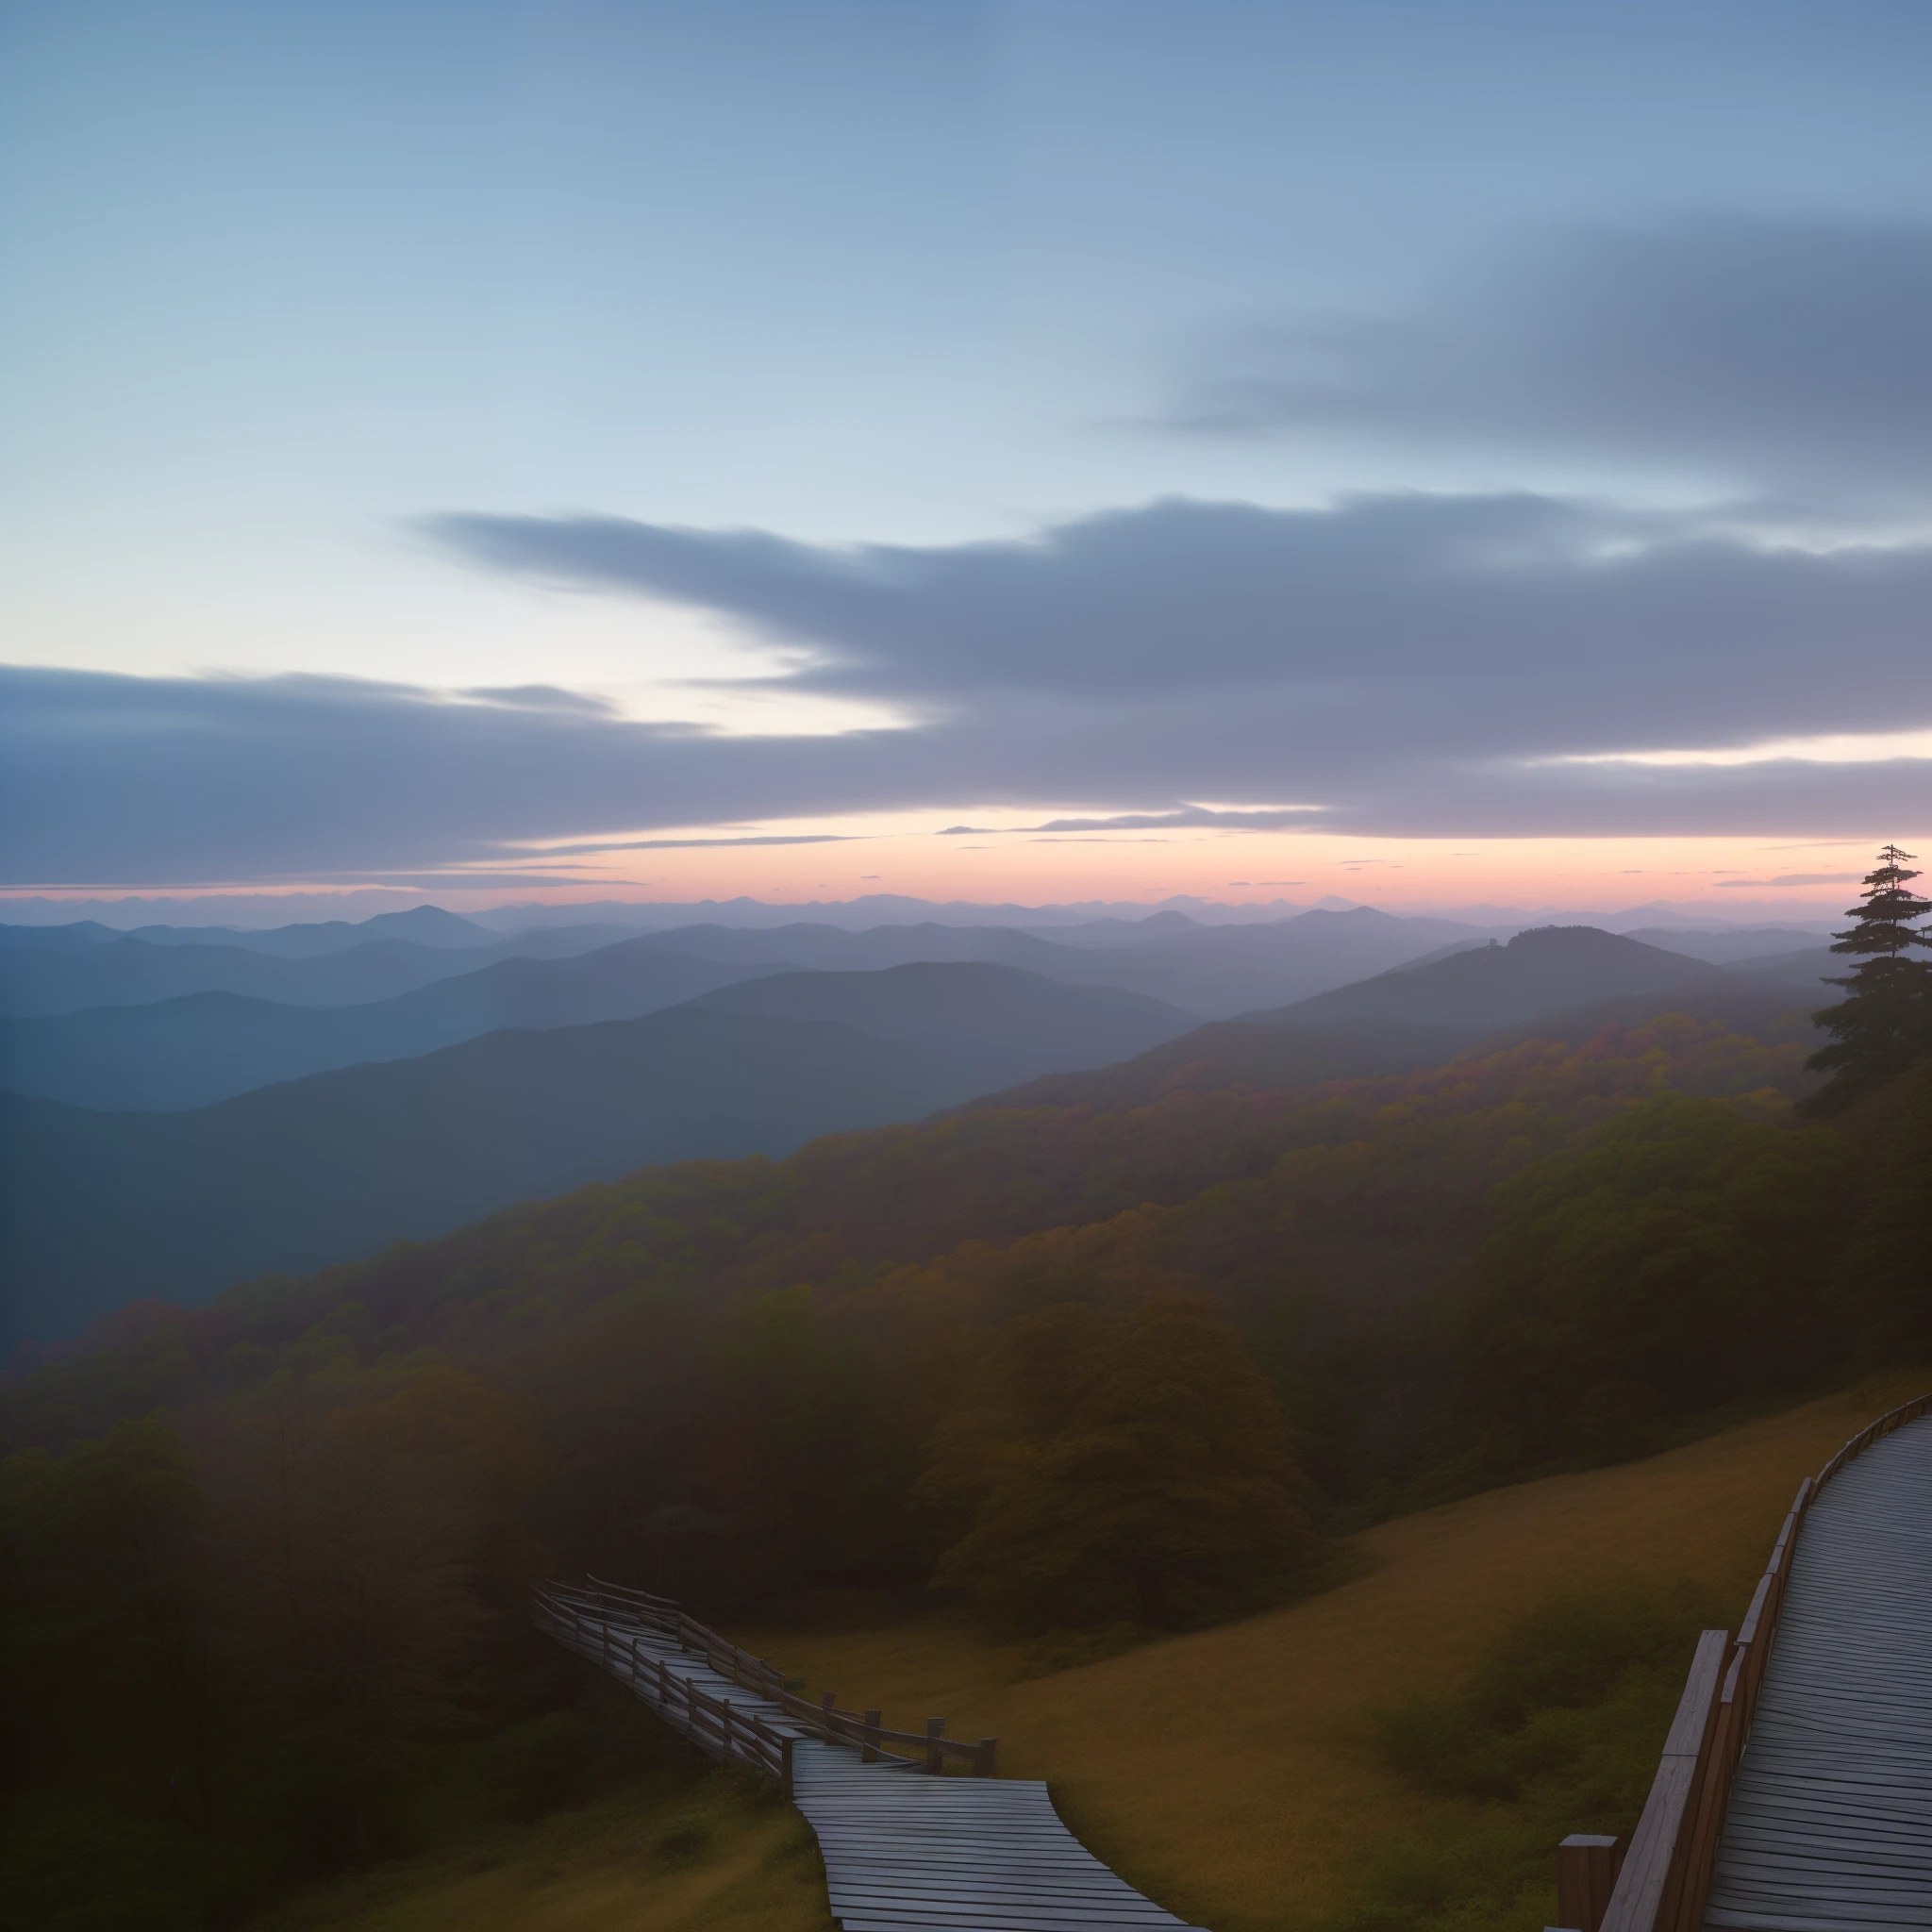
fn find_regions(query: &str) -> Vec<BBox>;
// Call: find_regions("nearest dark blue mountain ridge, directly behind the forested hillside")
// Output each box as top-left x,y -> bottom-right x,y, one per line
0,962 -> 1191,1337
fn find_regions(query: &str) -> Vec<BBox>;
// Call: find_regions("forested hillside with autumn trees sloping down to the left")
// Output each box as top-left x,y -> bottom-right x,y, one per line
4,1018 -> 1932,1924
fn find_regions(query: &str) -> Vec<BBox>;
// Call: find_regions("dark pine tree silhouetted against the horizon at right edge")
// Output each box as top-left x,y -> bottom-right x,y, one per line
1808,844 -> 1932,1113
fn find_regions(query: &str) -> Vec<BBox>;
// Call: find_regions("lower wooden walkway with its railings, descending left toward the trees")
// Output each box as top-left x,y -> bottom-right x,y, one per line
537,1584 -> 1192,1932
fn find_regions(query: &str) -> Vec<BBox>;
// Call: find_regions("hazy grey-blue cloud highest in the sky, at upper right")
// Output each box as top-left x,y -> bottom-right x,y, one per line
1163,214 -> 1932,500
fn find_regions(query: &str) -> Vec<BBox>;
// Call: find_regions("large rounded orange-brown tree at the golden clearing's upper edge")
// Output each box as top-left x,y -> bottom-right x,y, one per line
924,1294 -> 1312,1631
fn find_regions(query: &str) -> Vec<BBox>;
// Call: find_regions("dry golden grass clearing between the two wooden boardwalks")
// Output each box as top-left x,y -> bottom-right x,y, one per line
732,1372 -> 1924,1932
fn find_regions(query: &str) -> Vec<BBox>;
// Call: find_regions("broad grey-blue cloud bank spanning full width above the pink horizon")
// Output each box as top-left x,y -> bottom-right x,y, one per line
11,494 -> 1932,885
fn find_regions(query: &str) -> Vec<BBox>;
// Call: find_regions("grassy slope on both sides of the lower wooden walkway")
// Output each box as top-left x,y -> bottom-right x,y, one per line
263,1372 -> 1924,1932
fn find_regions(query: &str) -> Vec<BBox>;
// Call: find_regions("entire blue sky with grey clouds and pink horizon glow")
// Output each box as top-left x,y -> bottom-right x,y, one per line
0,0 -> 1932,918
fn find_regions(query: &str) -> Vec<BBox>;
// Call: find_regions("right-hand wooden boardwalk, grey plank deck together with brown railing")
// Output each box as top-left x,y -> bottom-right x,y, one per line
1557,1393 -> 1932,1932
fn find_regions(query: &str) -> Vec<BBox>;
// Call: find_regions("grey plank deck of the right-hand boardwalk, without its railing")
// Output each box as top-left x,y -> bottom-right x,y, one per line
1704,1416 -> 1932,1932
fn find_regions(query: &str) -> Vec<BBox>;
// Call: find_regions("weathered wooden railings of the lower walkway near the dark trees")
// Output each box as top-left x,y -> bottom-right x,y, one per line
537,1576 -> 999,1797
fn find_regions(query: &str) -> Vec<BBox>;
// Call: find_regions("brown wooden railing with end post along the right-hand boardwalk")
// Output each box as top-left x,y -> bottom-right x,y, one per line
1557,1395 -> 1932,1932
